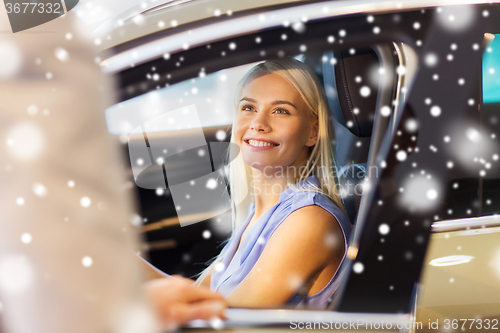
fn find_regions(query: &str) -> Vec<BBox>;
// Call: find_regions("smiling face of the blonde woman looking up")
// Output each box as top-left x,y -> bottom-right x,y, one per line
234,74 -> 317,171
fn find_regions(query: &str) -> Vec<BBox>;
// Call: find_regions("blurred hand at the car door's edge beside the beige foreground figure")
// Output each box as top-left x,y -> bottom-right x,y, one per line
143,278 -> 227,329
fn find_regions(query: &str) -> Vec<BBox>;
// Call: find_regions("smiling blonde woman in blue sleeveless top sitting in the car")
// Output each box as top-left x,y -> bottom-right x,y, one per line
197,58 -> 351,308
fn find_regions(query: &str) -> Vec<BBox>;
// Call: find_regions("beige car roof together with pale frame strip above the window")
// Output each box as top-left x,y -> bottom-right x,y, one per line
97,0 -> 499,72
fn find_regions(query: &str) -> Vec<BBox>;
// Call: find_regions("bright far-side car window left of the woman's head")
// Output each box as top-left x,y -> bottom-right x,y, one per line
106,64 -> 254,135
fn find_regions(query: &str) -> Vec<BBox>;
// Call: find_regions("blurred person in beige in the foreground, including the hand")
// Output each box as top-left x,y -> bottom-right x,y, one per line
0,6 -> 226,333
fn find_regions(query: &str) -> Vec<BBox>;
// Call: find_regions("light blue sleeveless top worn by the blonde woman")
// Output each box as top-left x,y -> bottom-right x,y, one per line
210,176 -> 351,309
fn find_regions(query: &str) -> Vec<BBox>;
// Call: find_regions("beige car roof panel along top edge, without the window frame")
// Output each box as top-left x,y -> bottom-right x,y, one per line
95,0 -> 497,49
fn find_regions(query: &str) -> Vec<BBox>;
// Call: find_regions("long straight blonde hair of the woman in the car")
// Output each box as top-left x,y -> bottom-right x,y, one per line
194,58 -> 345,283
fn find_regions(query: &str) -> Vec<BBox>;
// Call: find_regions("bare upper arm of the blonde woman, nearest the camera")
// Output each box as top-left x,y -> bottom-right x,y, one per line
227,206 -> 344,307
